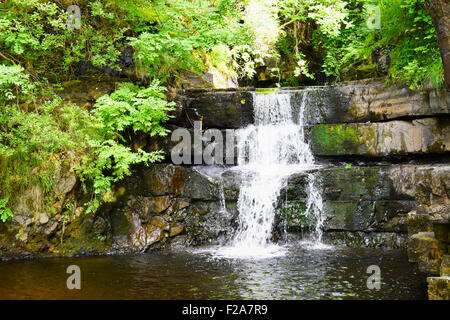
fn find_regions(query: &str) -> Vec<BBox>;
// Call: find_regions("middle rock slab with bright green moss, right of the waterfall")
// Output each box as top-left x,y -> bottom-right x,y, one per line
311,118 -> 450,157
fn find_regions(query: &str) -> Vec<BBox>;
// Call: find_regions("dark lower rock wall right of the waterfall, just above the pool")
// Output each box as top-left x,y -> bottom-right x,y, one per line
280,164 -> 450,247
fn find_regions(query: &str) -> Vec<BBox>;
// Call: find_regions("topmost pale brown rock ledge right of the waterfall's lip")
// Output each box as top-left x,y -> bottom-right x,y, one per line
284,79 -> 450,125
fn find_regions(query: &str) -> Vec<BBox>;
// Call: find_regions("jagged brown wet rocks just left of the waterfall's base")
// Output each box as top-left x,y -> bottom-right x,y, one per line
106,164 -> 237,251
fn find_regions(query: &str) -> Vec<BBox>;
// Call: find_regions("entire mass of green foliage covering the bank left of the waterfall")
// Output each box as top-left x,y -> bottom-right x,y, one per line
0,0 -> 252,220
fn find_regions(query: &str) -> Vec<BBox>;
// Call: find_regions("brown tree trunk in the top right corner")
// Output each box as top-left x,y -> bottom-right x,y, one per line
425,0 -> 450,91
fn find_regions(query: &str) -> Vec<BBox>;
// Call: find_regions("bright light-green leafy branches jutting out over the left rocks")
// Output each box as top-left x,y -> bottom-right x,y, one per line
79,80 -> 174,211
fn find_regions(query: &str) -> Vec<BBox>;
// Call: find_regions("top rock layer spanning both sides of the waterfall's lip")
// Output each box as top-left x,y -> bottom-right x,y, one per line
172,79 -> 450,129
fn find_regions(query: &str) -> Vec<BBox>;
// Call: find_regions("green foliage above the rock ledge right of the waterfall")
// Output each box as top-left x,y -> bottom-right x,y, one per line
270,0 -> 443,88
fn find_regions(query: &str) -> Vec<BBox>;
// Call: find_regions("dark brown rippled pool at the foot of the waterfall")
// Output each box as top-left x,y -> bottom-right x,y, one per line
0,245 -> 427,299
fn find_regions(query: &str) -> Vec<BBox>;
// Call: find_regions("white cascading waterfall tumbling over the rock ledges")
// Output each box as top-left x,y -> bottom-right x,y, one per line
211,91 -> 323,258
